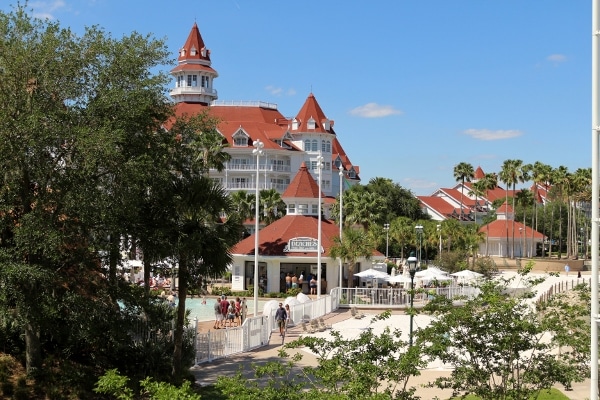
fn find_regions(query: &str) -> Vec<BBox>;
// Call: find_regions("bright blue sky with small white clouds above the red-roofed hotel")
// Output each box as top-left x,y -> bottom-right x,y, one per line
0,0 -> 591,195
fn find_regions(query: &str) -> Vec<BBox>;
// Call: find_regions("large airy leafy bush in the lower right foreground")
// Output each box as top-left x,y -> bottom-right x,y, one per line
417,268 -> 589,400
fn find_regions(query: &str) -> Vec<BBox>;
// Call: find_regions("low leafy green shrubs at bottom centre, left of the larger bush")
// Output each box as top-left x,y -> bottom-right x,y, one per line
216,311 -> 425,400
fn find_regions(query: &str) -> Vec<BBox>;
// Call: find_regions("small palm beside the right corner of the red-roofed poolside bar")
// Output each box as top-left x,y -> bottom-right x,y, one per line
329,228 -> 374,288
